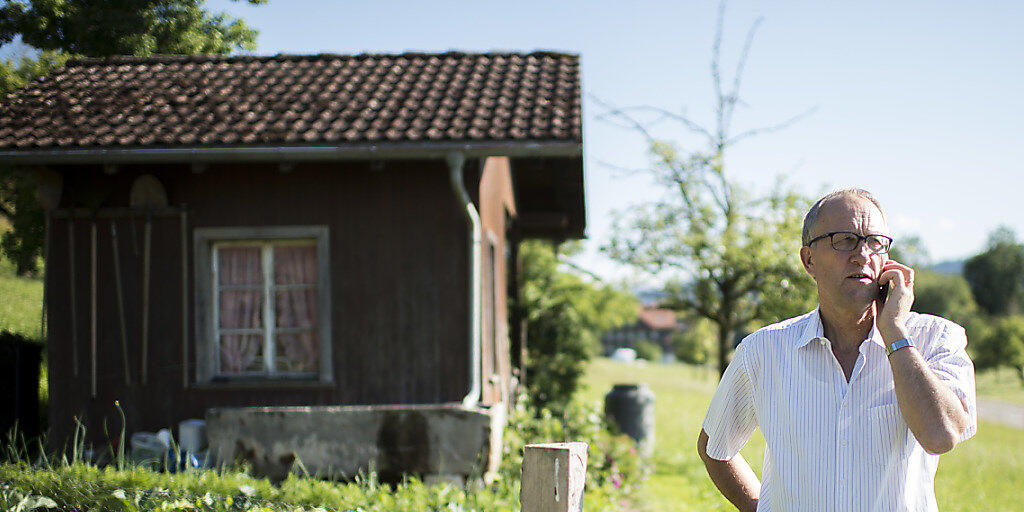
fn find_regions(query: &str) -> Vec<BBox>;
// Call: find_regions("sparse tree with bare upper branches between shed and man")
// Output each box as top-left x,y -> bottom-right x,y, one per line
602,3 -> 814,372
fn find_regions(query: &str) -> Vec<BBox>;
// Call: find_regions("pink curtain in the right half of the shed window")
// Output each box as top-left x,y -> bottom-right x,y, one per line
273,245 -> 319,372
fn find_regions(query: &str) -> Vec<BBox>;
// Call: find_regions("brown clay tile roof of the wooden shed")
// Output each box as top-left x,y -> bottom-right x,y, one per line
0,52 -> 582,151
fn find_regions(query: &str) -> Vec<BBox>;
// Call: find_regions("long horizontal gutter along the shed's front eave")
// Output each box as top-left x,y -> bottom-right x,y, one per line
0,141 -> 583,165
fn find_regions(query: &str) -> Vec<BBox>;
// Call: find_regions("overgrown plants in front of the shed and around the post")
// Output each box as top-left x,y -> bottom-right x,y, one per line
0,400 -> 644,512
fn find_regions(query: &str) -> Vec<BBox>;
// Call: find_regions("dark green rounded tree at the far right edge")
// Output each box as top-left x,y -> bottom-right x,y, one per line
964,227 -> 1024,315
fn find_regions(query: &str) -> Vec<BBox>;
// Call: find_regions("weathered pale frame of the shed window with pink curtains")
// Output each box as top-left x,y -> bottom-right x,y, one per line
193,225 -> 334,384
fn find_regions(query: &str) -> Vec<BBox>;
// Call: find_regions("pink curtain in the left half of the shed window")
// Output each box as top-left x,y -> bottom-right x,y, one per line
217,247 -> 263,374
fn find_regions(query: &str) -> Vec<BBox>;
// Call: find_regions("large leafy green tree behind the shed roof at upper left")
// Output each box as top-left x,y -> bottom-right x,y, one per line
0,0 -> 266,275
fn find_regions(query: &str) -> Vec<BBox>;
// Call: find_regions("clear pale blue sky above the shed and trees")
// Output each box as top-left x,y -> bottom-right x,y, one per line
24,0 -> 1024,276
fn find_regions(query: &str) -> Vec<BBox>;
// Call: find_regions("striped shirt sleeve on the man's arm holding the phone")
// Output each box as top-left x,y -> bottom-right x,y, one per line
923,322 -> 978,441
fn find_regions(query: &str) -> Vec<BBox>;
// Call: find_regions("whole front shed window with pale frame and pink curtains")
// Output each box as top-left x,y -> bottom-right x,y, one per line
195,226 -> 332,383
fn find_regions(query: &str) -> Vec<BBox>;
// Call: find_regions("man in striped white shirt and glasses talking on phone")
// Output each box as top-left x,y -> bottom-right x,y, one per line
697,189 -> 977,511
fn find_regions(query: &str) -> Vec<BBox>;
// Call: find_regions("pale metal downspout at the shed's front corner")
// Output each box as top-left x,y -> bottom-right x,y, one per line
444,152 -> 480,408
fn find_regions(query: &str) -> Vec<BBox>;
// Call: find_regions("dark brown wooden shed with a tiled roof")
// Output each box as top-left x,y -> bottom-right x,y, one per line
0,52 -> 585,474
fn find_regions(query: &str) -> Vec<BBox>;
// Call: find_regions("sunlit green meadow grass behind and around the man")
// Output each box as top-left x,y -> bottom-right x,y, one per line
584,358 -> 1024,512
